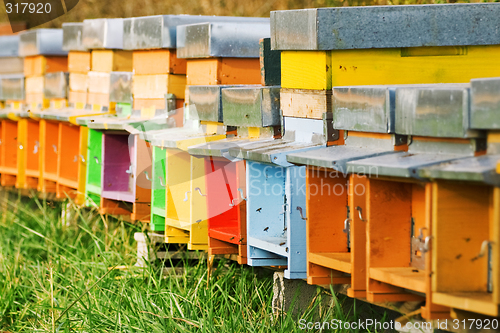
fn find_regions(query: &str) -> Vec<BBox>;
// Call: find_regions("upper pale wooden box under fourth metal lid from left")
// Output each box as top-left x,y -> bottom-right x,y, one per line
91,50 -> 133,73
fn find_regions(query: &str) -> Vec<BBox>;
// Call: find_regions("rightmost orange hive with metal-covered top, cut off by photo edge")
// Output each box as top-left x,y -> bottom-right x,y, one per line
414,79 -> 500,317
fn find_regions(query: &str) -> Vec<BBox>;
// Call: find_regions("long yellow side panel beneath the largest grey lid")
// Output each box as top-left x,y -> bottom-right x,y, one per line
332,45 -> 500,86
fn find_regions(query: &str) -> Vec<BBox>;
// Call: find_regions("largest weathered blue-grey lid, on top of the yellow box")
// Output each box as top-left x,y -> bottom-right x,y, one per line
271,3 -> 500,50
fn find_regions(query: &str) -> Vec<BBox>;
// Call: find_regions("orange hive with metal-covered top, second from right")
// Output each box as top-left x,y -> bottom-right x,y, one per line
348,85 -> 484,319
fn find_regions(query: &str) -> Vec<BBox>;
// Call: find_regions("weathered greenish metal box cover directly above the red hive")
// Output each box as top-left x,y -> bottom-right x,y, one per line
222,86 -> 281,127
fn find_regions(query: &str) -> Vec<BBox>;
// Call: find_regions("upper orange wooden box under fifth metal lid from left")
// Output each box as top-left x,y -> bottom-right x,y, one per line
132,49 -> 186,75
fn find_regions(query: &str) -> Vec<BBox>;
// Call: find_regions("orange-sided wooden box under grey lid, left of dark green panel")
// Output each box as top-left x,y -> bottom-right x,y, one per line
186,58 -> 260,85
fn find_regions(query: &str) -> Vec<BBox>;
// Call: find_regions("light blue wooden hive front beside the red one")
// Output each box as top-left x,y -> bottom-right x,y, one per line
246,161 -> 307,278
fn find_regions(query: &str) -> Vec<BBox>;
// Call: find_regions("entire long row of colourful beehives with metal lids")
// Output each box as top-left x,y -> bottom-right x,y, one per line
0,4 -> 500,319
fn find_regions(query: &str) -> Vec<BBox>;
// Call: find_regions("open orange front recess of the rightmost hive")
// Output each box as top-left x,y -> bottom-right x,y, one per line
432,181 -> 492,292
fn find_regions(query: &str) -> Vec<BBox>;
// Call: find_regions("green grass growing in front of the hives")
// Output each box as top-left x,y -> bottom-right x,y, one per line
0,191 -> 386,332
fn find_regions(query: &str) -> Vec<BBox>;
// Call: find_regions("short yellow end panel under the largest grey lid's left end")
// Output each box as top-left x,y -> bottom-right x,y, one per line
281,51 -> 332,90
